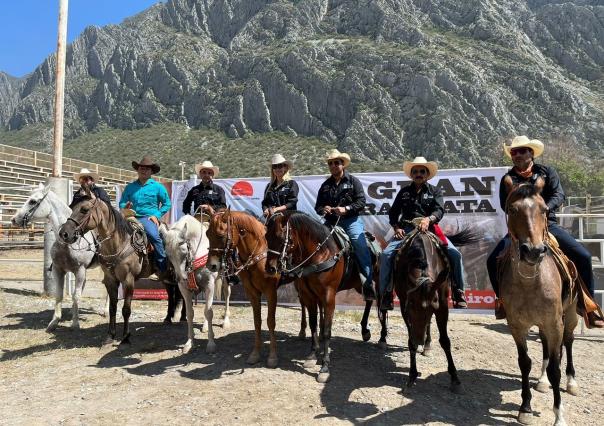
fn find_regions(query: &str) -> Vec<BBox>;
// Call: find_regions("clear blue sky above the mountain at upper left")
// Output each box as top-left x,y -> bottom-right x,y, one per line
0,0 -> 162,77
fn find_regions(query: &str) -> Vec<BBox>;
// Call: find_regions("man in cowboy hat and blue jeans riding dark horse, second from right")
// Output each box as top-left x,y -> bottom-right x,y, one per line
380,157 -> 467,310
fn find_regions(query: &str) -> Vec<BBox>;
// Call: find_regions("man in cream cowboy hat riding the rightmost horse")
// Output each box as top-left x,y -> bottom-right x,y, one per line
487,136 -> 604,327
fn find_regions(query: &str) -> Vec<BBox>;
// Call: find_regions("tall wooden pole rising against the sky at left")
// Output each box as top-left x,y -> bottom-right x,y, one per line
52,0 -> 68,177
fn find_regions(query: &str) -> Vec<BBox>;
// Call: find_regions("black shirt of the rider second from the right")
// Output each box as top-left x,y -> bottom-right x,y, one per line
388,183 -> 445,227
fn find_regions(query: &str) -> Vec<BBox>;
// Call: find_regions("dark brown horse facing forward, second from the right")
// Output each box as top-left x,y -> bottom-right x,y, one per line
380,230 -> 464,392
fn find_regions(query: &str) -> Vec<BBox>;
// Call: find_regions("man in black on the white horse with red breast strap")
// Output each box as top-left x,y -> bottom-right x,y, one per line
182,161 -> 226,218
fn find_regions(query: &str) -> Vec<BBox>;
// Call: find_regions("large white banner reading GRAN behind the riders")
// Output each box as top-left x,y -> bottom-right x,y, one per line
166,167 -> 507,309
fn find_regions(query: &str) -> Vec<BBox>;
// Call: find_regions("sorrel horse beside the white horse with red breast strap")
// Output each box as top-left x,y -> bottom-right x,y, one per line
207,209 -> 279,368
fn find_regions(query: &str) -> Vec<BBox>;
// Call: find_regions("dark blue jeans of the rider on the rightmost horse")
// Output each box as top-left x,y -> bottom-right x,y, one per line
487,222 -> 595,297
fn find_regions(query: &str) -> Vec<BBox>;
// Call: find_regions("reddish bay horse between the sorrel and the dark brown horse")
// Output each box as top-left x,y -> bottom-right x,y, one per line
266,211 -> 379,383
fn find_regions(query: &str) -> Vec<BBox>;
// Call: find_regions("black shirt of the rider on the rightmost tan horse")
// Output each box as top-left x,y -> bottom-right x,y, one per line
499,164 -> 565,223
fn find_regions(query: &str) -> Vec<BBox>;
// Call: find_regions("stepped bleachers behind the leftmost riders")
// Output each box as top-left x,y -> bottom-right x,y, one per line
0,144 -> 171,249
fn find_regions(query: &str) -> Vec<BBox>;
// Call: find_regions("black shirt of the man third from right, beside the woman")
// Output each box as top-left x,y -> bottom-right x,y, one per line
315,171 -> 365,225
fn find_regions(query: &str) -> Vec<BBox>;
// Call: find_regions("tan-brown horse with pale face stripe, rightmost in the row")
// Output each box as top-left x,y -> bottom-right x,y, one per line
500,179 -> 578,425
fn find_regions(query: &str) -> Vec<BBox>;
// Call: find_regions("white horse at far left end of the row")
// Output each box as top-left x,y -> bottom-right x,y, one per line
12,184 -> 107,332
